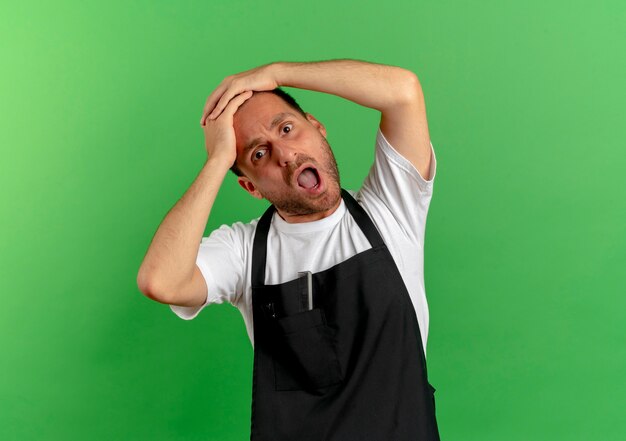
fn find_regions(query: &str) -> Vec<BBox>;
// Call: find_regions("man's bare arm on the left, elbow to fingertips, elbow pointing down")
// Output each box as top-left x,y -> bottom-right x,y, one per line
137,88 -> 252,306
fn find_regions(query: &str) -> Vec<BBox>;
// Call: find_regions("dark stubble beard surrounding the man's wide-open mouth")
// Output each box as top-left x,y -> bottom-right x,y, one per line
259,138 -> 341,216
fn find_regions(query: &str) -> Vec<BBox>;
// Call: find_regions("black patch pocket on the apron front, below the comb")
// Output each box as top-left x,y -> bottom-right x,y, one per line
273,308 -> 343,390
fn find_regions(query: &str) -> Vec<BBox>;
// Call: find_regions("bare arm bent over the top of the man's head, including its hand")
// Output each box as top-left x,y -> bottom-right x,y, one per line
200,60 -> 431,179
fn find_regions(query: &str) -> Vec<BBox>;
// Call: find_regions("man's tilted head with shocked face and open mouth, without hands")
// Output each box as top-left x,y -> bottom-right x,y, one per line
233,93 -> 341,222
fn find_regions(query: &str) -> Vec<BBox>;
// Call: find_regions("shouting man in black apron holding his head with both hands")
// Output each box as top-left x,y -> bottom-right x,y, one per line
138,60 -> 439,441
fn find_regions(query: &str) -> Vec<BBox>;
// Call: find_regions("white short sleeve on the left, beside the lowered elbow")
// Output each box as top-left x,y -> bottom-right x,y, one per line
170,223 -> 251,320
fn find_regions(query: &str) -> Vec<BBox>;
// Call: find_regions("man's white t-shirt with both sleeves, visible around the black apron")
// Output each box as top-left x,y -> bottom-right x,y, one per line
170,129 -> 436,351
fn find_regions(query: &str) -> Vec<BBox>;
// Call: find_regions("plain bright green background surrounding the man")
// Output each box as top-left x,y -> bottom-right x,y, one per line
0,0 -> 626,441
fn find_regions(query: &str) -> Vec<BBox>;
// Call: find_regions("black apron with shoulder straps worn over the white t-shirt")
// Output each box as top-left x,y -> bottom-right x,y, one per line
246,190 -> 439,441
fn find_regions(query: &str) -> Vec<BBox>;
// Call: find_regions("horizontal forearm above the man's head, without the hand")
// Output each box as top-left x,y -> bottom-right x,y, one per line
268,60 -> 420,112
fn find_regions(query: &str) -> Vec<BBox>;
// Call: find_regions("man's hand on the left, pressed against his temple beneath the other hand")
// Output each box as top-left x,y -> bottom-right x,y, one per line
202,91 -> 253,168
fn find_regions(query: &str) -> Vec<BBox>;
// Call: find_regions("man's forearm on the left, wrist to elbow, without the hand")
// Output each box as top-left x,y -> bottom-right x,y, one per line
137,159 -> 229,303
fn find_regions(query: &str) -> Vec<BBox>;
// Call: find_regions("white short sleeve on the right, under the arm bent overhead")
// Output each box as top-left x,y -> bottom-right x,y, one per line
360,128 -> 437,239
